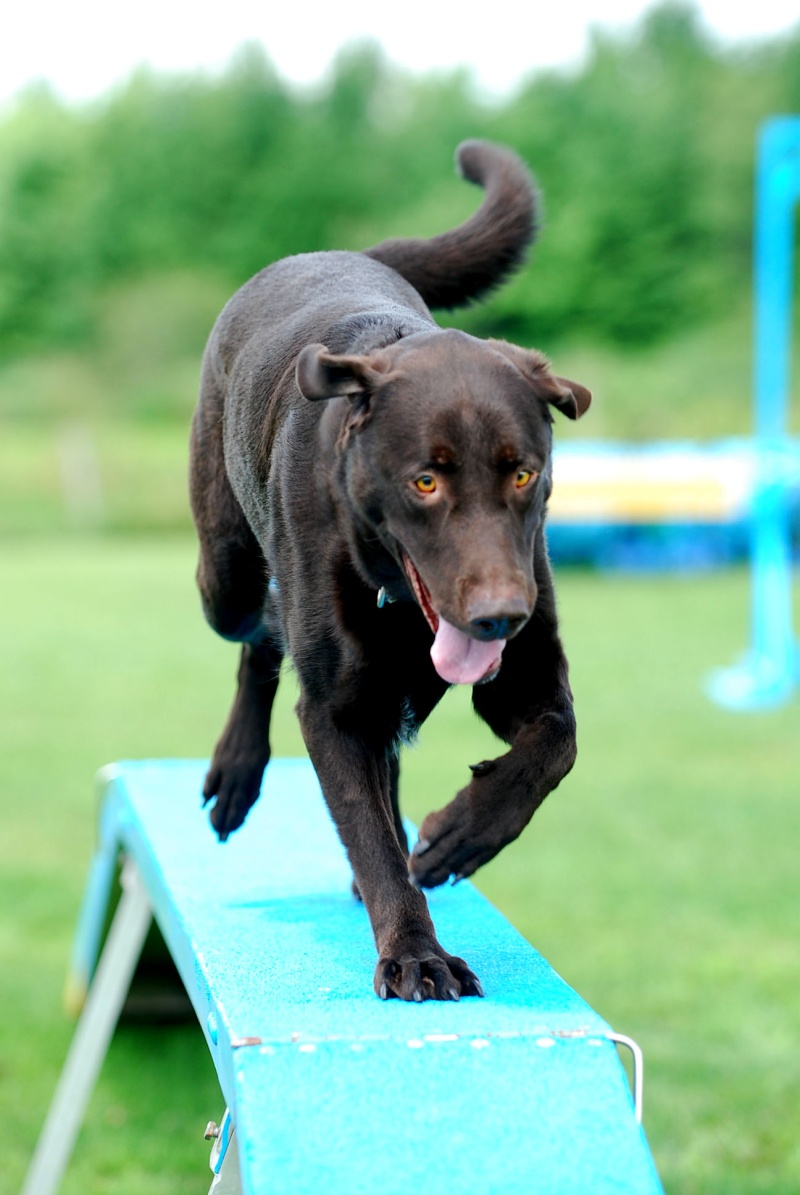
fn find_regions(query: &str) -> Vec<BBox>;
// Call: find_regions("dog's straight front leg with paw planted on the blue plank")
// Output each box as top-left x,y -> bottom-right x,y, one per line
298,698 -> 483,1000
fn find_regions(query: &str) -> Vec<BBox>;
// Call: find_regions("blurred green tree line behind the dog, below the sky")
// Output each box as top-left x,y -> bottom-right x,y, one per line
0,4 -> 800,366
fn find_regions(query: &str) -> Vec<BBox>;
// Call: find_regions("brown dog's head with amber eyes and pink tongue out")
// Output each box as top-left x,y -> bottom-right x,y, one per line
297,330 -> 591,684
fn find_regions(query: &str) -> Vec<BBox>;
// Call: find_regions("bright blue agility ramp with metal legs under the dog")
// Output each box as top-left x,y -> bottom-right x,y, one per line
24,760 -> 661,1195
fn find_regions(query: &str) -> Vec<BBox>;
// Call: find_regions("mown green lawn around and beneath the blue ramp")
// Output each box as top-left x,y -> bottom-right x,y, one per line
0,535 -> 800,1195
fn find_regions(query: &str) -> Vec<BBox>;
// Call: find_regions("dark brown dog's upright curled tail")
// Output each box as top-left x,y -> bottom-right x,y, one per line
365,141 -> 538,307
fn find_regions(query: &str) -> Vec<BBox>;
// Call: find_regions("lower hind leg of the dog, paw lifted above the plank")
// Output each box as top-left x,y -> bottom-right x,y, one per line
203,642 -> 282,842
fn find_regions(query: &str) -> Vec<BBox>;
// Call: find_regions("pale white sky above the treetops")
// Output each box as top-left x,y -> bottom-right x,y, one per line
0,0 -> 800,100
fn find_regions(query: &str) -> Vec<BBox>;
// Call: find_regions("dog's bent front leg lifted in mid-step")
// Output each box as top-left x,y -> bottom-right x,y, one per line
409,559 -> 576,888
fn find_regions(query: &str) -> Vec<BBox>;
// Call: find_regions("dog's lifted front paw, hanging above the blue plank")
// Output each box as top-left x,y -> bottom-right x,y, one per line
408,762 -> 533,888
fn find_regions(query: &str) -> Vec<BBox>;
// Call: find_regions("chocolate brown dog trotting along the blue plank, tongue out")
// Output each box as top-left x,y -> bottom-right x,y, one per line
190,141 -> 591,1000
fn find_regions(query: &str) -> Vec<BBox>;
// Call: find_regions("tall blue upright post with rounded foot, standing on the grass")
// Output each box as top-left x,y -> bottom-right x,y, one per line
709,116 -> 800,710
